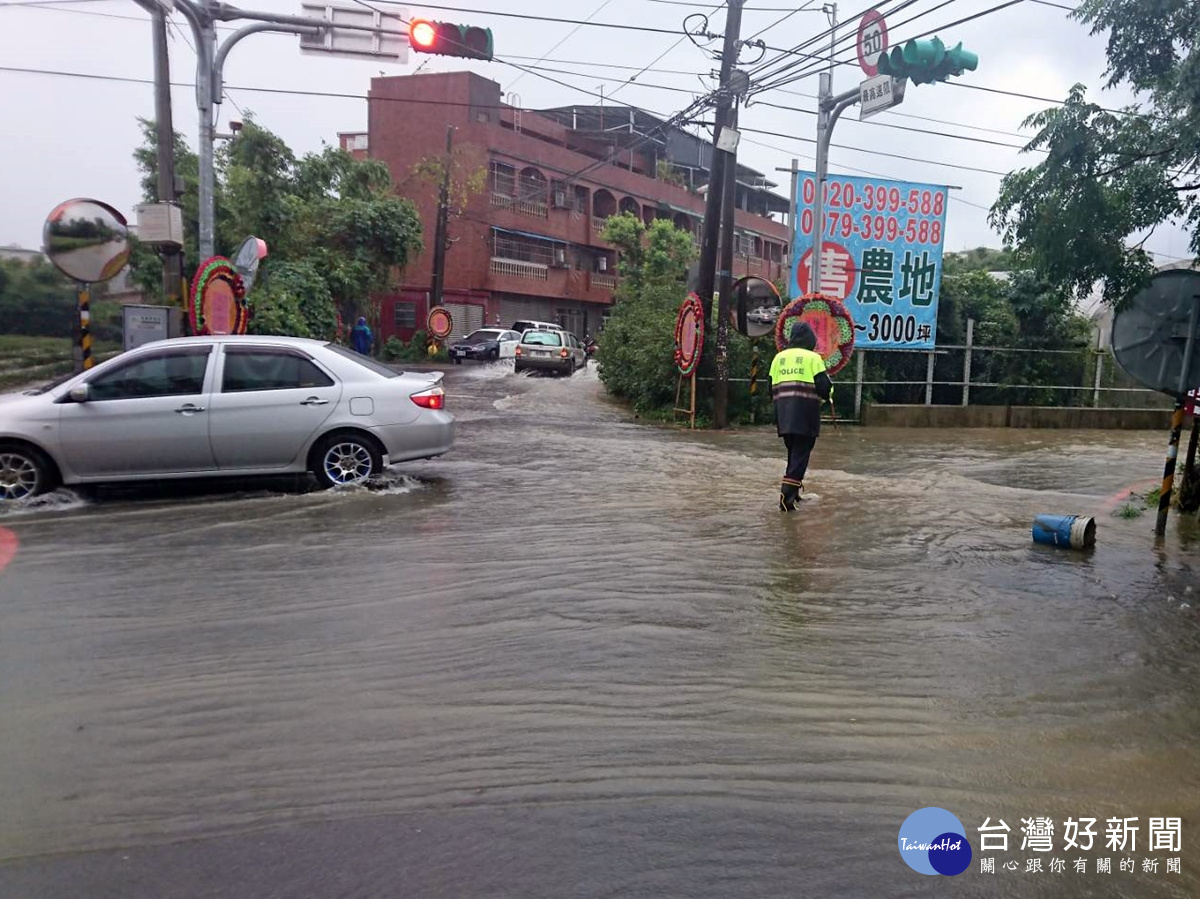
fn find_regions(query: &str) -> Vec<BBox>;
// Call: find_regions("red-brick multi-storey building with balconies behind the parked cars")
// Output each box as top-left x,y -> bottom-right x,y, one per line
338,72 -> 788,340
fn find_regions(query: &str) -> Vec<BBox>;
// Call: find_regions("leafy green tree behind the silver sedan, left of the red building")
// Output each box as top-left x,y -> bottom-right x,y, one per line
132,114 -> 422,337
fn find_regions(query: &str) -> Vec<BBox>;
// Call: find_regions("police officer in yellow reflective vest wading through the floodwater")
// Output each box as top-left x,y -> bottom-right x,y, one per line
770,322 -> 833,513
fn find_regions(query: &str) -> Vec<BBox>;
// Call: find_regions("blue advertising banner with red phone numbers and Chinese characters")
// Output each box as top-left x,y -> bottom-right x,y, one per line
791,172 -> 948,349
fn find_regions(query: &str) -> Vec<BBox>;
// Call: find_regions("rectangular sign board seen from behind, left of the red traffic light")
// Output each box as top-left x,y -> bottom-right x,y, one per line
300,2 -> 410,62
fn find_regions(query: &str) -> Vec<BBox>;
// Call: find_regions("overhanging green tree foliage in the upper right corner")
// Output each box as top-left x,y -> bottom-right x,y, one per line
991,0 -> 1200,305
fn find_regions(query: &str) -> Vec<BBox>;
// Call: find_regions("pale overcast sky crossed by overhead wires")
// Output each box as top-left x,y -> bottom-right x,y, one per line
0,0 -> 1188,258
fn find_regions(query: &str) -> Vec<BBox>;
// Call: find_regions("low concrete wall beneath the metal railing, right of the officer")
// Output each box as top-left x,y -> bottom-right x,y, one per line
863,403 -> 1171,431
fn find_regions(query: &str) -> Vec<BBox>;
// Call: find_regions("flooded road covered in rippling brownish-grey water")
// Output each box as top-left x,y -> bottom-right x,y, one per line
0,366 -> 1200,899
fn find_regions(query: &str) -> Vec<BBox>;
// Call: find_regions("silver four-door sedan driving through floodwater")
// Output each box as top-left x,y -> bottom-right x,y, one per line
0,336 -> 455,502
